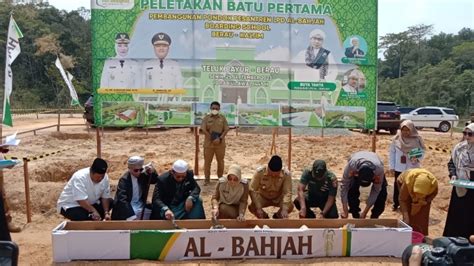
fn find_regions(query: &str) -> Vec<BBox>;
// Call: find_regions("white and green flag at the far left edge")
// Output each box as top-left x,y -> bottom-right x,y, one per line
2,16 -> 23,126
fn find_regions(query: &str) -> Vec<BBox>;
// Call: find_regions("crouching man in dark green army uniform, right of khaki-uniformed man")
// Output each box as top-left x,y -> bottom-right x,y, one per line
293,160 -> 339,218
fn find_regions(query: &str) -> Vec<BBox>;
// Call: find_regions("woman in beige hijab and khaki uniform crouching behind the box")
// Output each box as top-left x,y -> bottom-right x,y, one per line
211,164 -> 249,221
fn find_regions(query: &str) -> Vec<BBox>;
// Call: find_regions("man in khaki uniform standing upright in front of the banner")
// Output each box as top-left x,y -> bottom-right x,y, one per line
201,102 -> 229,185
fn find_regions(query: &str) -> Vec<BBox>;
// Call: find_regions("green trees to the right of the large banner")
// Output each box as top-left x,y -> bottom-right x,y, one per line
378,25 -> 474,115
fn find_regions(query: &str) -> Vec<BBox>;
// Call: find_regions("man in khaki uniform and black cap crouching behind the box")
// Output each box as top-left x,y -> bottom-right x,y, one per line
249,155 -> 293,219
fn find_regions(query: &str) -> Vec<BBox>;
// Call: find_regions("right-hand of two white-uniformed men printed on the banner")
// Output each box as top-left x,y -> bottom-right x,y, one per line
143,32 -> 183,102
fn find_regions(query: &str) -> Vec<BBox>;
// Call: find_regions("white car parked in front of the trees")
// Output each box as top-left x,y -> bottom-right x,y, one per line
400,106 -> 459,132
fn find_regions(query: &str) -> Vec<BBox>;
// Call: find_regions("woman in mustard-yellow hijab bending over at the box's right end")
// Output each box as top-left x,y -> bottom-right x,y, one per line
397,168 -> 438,235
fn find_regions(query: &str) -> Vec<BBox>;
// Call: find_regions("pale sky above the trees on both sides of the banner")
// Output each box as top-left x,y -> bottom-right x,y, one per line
49,0 -> 474,36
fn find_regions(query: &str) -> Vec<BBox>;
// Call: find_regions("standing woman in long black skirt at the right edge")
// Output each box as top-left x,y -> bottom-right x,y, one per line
443,123 -> 474,238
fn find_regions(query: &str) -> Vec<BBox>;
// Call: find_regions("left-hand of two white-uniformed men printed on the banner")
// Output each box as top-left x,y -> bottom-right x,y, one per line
100,32 -> 141,89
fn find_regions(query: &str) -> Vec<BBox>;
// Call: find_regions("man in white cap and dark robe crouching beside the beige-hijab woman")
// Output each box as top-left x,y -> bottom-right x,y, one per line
151,160 -> 206,220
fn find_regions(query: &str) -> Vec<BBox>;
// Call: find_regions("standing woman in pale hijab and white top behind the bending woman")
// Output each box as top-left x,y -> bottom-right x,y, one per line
389,120 -> 425,211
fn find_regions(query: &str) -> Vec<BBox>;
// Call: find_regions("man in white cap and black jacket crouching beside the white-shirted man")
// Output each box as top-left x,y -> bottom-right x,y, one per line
112,156 -> 158,221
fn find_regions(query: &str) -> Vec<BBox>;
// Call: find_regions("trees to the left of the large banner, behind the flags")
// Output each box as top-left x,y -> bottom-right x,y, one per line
0,3 -> 92,109
